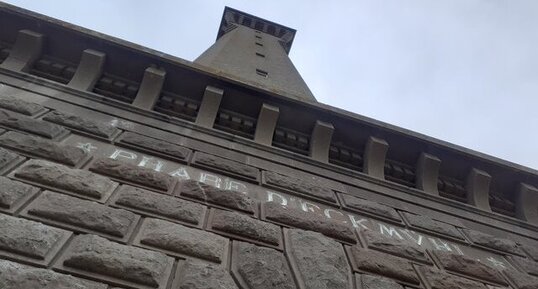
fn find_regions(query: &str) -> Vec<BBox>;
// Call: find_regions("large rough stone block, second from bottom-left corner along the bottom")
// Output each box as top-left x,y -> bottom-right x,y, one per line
63,235 -> 173,288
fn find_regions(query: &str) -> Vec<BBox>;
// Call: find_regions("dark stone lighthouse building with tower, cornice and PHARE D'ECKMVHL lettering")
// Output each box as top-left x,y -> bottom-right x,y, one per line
0,4 -> 538,289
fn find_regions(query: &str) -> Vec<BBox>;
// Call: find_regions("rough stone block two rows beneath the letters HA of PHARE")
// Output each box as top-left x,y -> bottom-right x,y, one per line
115,185 -> 205,225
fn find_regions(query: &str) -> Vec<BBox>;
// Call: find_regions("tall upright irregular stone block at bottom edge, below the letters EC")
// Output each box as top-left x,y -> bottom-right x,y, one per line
286,229 -> 349,289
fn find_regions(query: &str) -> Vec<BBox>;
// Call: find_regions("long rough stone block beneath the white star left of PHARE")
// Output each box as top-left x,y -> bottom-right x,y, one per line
15,160 -> 114,199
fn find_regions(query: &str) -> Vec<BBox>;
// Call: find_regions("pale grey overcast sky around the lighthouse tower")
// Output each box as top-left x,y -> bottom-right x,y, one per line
7,0 -> 538,169
